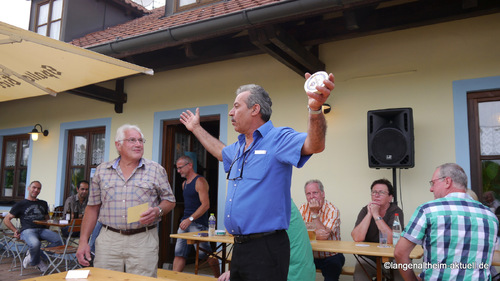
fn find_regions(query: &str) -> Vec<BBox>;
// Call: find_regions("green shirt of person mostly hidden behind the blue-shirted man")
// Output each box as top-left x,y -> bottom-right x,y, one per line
286,201 -> 316,281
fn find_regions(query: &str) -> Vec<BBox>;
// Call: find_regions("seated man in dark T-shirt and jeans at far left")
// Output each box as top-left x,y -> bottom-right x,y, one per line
4,181 -> 62,272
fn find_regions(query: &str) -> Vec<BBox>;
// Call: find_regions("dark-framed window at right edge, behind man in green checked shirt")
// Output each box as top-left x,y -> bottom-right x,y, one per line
467,91 -> 500,208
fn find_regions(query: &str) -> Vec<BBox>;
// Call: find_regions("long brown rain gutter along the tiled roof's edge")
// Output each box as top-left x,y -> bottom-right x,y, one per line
88,0 -> 344,55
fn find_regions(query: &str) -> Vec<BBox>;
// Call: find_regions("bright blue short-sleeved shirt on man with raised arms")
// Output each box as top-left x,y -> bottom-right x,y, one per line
222,121 -> 310,235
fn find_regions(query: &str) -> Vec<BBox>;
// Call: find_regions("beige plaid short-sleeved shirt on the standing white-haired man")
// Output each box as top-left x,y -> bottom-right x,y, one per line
87,158 -> 175,229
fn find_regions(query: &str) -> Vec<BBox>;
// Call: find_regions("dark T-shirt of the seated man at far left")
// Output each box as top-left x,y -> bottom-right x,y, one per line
9,199 -> 49,233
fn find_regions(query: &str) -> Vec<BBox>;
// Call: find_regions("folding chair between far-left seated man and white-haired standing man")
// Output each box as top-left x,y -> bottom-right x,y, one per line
42,219 -> 82,275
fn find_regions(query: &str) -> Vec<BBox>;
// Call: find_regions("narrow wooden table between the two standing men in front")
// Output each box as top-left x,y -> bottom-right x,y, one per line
170,231 -> 234,274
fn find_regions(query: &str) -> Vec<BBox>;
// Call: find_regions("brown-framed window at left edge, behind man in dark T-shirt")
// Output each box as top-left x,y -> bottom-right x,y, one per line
0,134 -> 30,202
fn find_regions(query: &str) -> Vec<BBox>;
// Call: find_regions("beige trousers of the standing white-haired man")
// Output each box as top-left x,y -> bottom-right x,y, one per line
94,226 -> 159,277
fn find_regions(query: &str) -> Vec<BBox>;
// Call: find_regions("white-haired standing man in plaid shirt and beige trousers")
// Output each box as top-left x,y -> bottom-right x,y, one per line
77,124 -> 175,277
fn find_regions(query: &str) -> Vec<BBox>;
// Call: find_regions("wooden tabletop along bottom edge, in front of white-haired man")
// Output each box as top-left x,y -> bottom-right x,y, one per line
19,267 -> 211,281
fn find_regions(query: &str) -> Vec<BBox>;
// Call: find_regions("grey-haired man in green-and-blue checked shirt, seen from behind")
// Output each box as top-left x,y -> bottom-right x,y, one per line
394,163 -> 498,280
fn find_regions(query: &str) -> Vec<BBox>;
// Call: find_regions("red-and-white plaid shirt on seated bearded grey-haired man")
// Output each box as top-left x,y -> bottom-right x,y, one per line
299,200 -> 340,259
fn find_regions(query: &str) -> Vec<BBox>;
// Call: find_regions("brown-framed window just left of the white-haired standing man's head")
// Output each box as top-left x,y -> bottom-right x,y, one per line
64,127 -> 106,198
